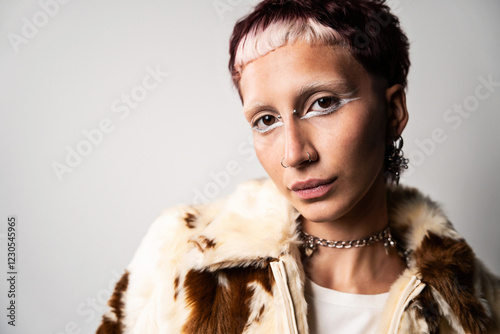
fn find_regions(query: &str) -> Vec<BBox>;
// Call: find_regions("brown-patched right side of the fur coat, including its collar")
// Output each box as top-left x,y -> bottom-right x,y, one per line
388,186 -> 500,333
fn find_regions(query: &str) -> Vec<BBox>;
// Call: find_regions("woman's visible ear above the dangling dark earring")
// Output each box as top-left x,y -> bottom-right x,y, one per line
385,84 -> 409,141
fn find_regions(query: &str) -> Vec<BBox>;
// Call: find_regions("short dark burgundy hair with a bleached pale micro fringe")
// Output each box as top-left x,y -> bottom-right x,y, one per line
229,0 -> 410,90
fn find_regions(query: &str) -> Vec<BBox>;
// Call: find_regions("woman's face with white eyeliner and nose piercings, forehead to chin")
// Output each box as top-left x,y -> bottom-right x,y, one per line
240,42 -> 400,222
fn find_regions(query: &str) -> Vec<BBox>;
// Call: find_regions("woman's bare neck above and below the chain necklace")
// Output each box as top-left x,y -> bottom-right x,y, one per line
301,176 -> 405,294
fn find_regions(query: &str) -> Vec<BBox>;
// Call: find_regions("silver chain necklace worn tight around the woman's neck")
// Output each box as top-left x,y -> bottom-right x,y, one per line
300,226 -> 396,256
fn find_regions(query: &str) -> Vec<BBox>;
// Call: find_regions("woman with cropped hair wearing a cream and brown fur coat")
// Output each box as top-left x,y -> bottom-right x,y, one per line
98,0 -> 500,334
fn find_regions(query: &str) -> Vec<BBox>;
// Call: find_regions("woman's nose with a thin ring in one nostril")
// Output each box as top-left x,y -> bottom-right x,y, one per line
282,117 -> 313,167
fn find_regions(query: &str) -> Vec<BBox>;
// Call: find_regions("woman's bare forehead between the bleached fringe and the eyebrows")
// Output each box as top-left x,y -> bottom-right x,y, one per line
240,42 -> 372,104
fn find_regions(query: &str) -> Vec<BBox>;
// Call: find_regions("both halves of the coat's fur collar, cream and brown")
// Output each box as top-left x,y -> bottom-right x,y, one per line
184,179 -> 462,270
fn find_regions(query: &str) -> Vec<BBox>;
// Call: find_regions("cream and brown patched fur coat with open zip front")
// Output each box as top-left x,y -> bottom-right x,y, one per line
97,180 -> 500,334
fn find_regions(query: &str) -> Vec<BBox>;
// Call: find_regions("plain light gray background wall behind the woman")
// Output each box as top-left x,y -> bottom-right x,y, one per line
0,0 -> 500,334
